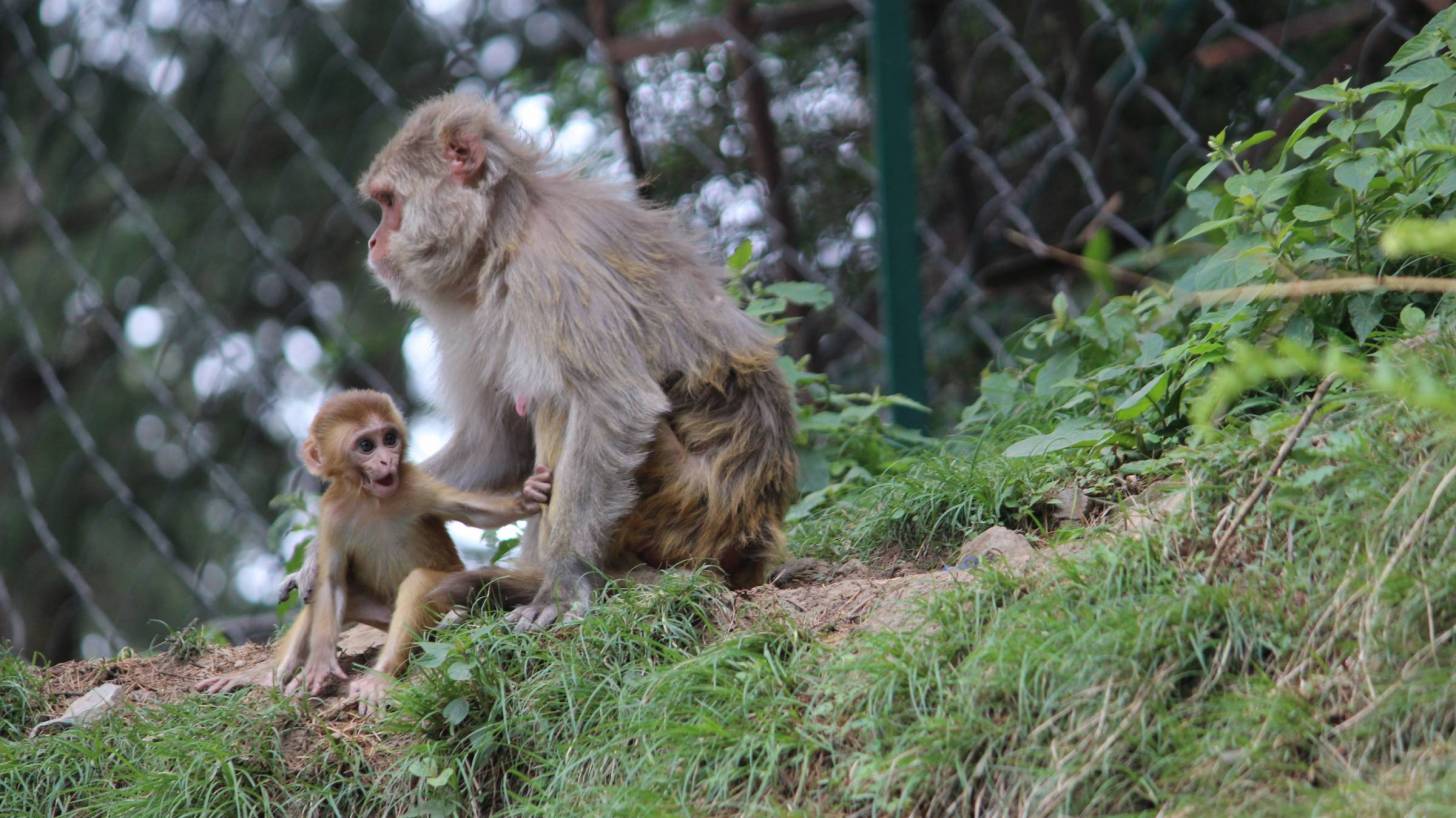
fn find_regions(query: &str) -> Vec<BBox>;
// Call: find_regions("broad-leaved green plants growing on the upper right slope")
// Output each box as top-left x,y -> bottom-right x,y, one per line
961,9 -> 1456,470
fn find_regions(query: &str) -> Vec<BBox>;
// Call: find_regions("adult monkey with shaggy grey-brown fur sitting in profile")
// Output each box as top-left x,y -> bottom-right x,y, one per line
342,95 -> 798,629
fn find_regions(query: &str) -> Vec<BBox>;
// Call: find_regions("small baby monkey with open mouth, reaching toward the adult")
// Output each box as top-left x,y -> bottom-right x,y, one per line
197,390 -> 550,712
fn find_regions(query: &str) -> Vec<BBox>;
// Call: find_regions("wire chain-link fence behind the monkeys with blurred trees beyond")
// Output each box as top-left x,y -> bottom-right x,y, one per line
0,0 -> 1444,658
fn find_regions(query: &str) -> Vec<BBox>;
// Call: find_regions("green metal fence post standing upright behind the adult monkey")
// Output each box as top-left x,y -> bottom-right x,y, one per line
869,0 -> 927,428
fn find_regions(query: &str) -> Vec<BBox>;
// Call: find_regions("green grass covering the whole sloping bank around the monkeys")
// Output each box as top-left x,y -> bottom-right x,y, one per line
8,336 -> 1456,817
